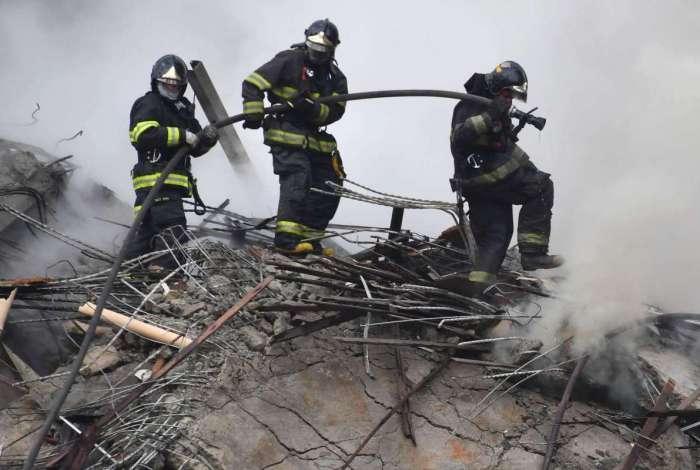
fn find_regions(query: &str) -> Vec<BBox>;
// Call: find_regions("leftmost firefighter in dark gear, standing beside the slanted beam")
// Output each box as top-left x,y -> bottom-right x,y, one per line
129,55 -> 218,264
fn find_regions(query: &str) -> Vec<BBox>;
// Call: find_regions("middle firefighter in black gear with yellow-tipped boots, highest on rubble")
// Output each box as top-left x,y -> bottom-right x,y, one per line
242,19 -> 348,255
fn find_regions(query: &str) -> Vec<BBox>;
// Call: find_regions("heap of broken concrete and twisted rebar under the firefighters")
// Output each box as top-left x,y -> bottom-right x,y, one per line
0,138 -> 700,469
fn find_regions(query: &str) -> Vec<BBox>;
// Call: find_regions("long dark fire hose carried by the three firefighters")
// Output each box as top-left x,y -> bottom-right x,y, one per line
22,90 -> 516,470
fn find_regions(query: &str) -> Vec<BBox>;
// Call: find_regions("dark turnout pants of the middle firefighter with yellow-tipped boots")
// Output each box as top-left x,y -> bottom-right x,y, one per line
271,147 -> 342,248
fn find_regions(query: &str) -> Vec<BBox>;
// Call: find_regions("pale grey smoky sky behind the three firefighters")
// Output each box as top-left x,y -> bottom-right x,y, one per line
0,0 -> 700,310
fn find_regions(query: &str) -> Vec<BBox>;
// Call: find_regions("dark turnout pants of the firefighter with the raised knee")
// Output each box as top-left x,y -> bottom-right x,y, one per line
464,162 -> 554,282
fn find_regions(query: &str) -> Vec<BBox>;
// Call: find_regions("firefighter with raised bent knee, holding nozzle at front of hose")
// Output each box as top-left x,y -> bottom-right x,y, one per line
450,61 -> 564,293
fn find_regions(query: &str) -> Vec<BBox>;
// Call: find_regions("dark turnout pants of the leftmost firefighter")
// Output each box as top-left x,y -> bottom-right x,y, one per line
127,189 -> 187,267
